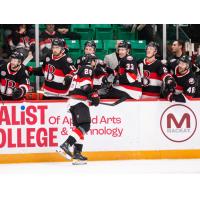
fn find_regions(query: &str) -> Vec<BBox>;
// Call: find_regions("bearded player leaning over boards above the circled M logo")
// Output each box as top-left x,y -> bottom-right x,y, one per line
163,56 -> 196,102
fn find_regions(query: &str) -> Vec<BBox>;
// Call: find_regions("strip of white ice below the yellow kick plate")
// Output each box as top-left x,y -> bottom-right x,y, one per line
0,159 -> 200,175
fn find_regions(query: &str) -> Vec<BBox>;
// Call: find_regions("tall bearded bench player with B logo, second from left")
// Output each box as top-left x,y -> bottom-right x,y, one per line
32,39 -> 76,99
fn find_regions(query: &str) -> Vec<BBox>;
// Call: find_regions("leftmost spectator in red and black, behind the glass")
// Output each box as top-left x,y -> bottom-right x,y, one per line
8,24 -> 35,58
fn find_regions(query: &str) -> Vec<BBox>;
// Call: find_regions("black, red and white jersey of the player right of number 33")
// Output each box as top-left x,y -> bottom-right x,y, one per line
138,59 -> 171,98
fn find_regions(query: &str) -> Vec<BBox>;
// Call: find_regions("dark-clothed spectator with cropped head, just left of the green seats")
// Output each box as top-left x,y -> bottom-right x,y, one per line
56,24 -> 81,40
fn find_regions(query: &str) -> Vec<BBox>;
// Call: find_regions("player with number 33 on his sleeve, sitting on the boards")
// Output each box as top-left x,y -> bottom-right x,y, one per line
101,41 -> 142,100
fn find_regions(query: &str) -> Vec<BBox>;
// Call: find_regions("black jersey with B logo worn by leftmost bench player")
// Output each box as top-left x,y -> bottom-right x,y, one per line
0,63 -> 30,100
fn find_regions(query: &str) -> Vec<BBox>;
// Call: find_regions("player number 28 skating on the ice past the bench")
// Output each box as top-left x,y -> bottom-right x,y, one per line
58,54 -> 100,164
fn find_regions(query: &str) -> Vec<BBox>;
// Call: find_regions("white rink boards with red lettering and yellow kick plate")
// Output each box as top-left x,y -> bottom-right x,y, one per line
0,100 -> 200,163
